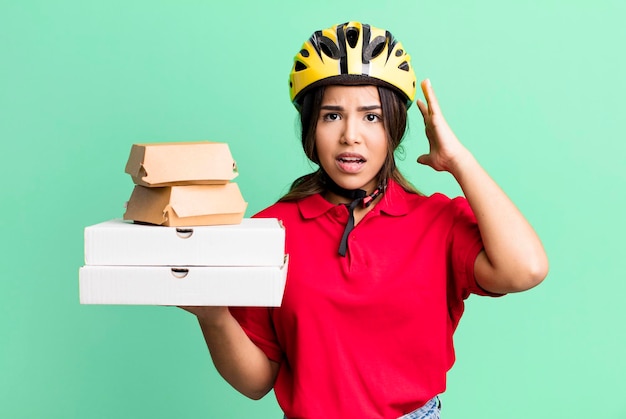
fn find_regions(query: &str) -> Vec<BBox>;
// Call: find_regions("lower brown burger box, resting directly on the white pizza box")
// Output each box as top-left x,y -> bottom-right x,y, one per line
123,182 -> 248,227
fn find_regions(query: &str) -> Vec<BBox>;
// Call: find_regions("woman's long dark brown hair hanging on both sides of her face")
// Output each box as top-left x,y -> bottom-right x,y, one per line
279,86 -> 420,201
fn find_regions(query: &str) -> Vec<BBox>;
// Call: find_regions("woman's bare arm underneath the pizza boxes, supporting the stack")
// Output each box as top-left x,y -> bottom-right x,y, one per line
181,307 -> 279,400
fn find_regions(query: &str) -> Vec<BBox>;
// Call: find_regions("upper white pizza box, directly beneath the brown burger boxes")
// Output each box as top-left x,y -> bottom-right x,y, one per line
84,218 -> 285,266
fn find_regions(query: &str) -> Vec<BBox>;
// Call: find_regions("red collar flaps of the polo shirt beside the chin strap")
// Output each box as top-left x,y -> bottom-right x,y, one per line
298,179 -> 408,219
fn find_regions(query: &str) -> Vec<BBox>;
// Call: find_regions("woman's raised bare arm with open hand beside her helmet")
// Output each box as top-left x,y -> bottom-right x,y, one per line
417,80 -> 548,293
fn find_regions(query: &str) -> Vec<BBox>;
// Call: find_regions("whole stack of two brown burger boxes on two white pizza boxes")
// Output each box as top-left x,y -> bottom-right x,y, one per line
79,142 -> 288,306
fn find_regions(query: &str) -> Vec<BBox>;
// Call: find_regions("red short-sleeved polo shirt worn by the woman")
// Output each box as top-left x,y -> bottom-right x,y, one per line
231,182 -> 494,419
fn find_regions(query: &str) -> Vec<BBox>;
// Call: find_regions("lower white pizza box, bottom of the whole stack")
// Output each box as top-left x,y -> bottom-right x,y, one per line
79,258 -> 288,307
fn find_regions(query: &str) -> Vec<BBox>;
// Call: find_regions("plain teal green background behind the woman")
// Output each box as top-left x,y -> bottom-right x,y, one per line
0,0 -> 626,419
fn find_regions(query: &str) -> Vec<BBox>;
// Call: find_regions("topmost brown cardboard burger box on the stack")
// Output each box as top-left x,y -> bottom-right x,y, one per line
125,141 -> 238,187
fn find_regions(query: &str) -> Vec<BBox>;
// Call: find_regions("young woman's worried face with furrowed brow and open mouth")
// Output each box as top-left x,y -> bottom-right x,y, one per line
315,86 -> 387,197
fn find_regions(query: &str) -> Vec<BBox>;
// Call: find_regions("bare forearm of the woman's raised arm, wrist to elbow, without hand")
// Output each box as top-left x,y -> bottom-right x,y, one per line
451,151 -> 548,293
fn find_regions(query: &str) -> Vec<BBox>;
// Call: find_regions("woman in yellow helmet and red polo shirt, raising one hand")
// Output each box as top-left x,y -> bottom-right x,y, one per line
186,22 -> 548,418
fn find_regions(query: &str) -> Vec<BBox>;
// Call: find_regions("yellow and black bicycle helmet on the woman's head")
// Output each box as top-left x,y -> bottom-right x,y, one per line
289,22 -> 416,109
